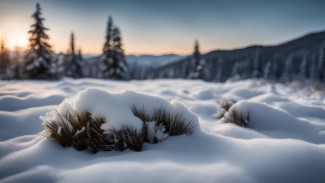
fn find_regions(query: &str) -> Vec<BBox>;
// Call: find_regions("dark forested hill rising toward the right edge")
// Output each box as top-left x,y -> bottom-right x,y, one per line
152,31 -> 325,81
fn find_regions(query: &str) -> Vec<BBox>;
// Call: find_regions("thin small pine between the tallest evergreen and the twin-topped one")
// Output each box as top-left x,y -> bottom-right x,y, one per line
66,32 -> 83,78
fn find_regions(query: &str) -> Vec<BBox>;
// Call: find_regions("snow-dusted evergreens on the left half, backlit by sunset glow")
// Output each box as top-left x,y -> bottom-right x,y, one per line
0,3 -> 129,79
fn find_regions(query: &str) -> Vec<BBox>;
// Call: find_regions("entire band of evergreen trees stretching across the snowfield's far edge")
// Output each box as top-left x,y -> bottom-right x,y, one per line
0,3 -> 325,82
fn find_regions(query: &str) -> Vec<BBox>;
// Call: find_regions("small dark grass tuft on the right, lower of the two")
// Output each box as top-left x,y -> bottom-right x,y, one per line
224,109 -> 249,127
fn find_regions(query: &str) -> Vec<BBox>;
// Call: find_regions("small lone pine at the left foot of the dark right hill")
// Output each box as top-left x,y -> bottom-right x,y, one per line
188,40 -> 208,79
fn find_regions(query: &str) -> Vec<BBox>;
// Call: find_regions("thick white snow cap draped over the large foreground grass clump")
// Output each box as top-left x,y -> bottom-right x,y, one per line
41,88 -> 199,131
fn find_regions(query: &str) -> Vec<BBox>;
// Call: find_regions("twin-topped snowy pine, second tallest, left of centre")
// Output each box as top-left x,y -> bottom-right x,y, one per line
100,17 -> 128,79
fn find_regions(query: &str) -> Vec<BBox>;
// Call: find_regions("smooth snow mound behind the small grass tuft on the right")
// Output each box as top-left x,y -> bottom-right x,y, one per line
226,101 -> 325,144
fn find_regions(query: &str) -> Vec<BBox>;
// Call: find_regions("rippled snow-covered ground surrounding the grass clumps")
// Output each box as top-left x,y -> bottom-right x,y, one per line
0,79 -> 325,183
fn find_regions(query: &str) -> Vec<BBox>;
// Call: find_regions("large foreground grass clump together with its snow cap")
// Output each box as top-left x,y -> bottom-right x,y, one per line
41,89 -> 199,153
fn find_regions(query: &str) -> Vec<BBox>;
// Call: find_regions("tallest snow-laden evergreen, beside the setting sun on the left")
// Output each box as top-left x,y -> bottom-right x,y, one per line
25,3 -> 56,79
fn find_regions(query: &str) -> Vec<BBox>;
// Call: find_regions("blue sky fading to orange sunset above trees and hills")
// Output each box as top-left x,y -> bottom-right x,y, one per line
0,0 -> 325,55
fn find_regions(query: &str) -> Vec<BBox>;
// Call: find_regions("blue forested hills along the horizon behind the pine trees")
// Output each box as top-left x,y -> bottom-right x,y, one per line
84,31 -> 325,81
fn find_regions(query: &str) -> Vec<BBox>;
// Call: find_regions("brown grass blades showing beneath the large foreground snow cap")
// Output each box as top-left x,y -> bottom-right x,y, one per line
43,106 -> 195,153
